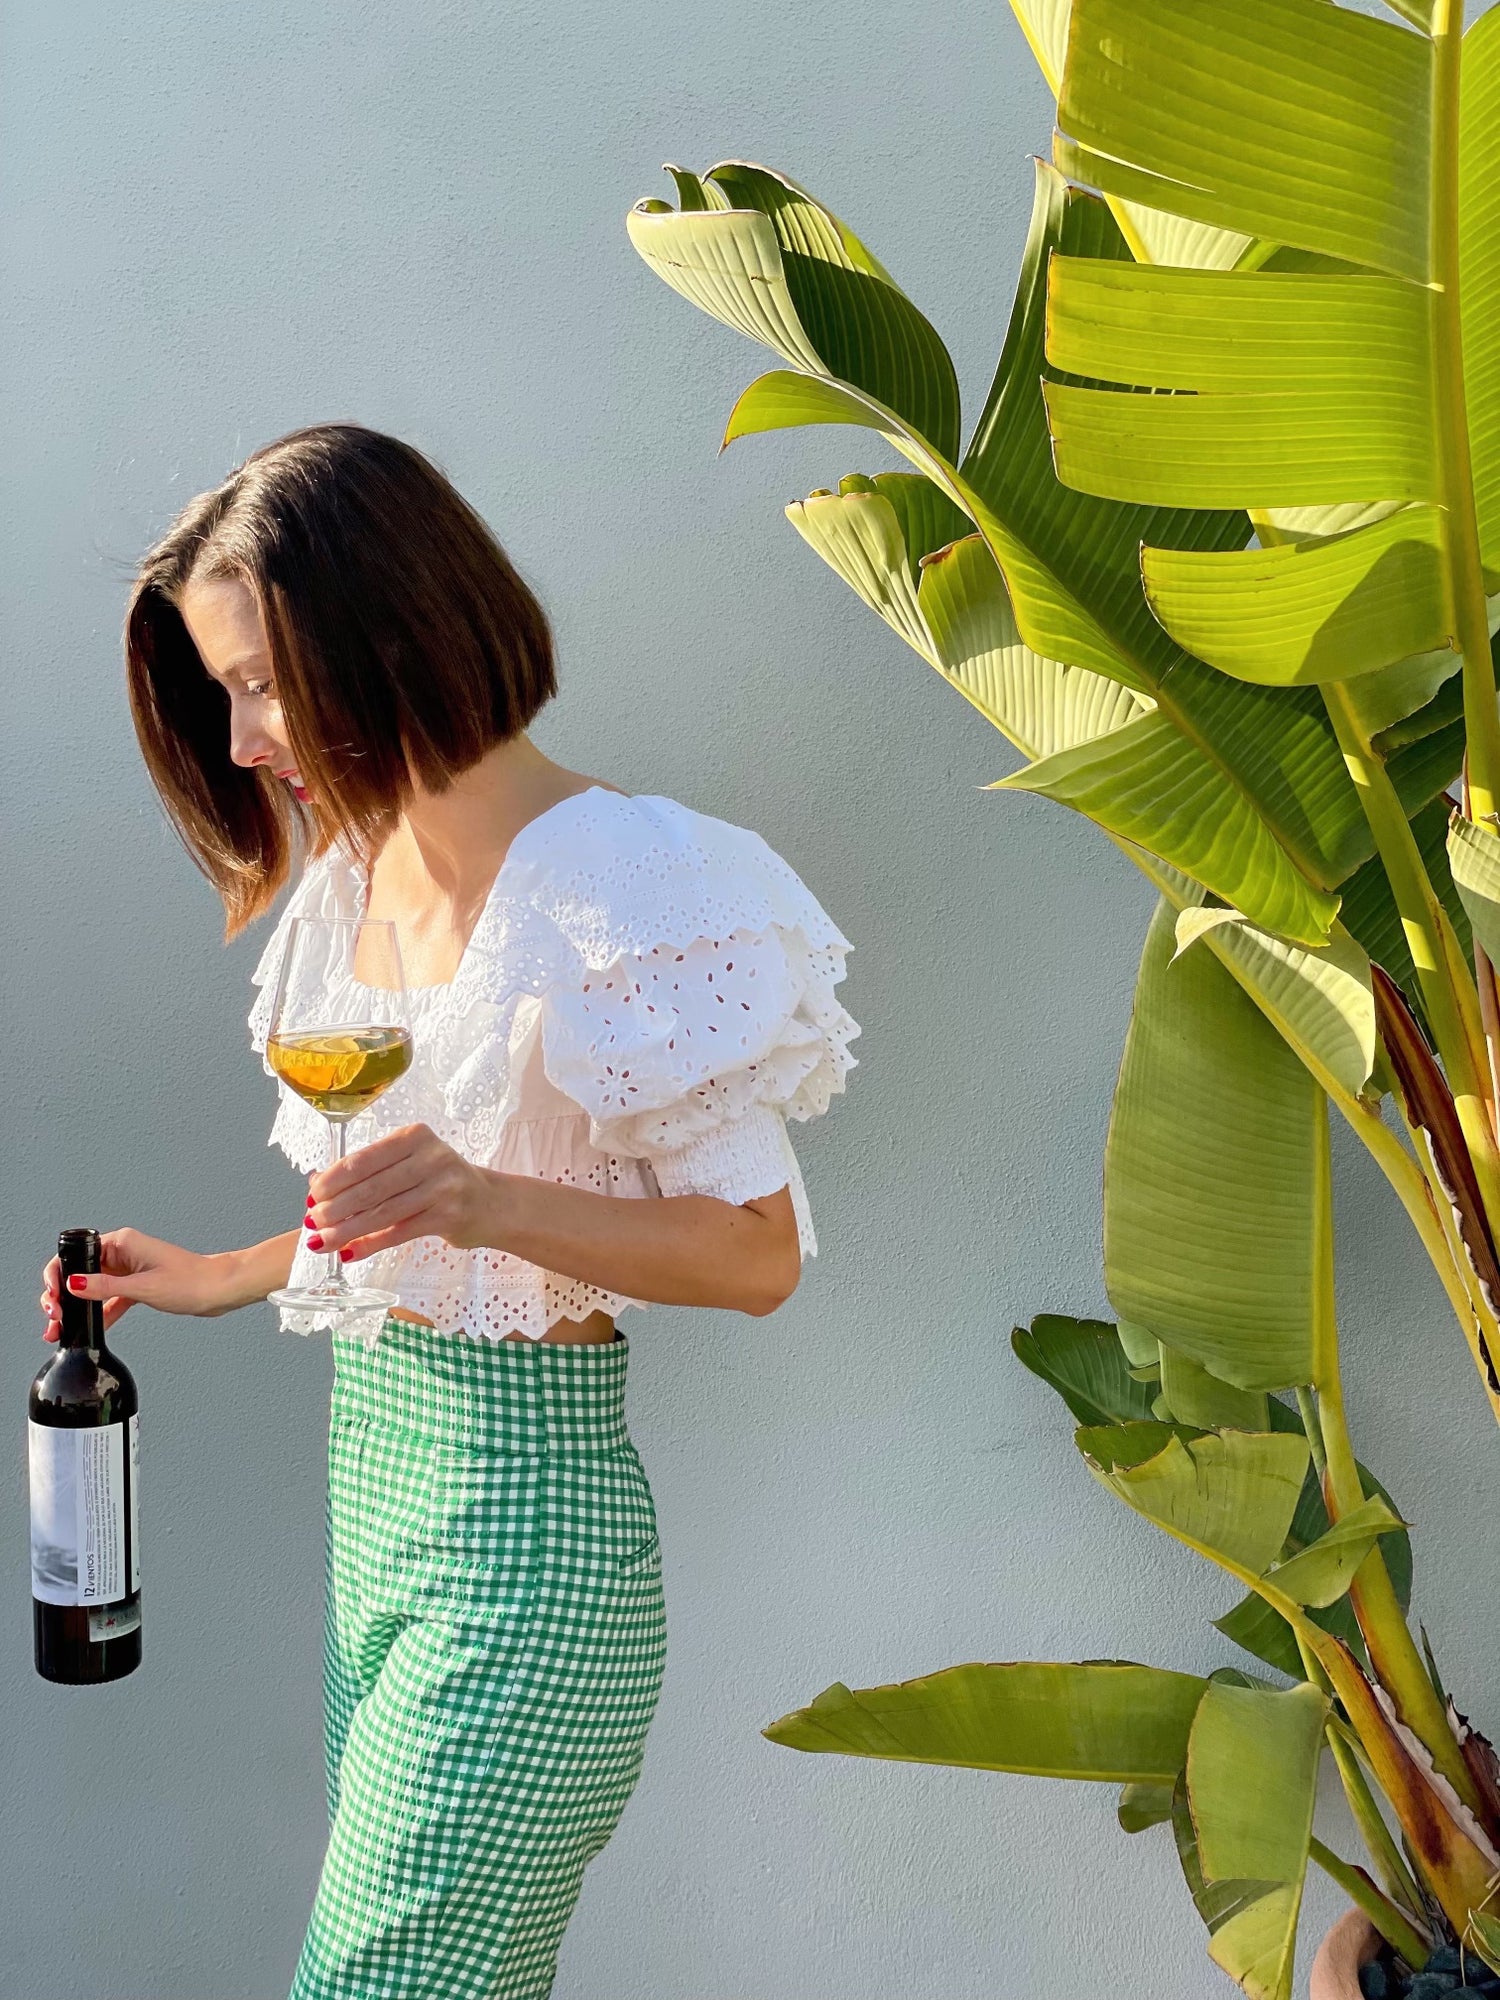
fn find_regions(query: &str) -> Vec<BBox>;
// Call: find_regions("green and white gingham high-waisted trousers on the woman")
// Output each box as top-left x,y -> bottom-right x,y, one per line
292,1318 -> 666,2000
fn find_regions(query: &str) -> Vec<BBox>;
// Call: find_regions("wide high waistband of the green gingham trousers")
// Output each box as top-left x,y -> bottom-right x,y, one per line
332,1318 -> 630,1454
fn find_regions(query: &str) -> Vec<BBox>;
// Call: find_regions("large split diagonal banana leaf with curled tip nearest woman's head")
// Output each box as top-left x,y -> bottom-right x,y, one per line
630,152 -> 1400,942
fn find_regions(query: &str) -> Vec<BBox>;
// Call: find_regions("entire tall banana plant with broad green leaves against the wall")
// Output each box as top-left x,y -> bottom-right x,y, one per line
628,0 -> 1500,1996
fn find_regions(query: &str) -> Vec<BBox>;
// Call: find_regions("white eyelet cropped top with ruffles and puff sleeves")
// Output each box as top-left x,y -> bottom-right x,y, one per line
250,786 -> 860,1340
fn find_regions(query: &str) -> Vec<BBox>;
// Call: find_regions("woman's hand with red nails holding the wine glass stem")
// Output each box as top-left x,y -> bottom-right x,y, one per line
306,1126 -> 494,1258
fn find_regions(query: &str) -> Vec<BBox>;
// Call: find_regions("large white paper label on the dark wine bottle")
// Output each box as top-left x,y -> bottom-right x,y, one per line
26,1418 -> 138,1604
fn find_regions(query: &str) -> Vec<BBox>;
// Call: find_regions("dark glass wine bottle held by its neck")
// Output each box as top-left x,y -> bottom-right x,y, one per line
26,1230 -> 140,1686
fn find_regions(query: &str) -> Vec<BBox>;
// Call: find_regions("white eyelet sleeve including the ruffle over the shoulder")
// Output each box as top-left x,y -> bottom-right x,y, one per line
532,798 -> 860,1254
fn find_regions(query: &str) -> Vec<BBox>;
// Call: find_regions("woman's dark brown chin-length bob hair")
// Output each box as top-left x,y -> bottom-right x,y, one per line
124,424 -> 556,938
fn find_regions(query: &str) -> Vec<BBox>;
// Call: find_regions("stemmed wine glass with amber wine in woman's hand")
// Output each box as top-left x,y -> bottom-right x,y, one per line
266,916 -> 412,1328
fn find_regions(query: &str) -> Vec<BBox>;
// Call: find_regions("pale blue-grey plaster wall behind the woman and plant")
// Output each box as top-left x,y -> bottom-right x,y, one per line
0,0 -> 1500,2000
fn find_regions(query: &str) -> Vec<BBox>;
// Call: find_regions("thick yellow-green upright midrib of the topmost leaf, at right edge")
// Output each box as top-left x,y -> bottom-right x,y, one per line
1428,0 -> 1500,820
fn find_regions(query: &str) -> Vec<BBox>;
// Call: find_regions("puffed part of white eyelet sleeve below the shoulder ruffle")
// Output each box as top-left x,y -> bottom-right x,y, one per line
542,864 -> 860,1256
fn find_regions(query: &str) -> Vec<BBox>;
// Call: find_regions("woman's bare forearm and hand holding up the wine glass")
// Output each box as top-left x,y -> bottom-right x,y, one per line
308,1126 -> 802,1314
